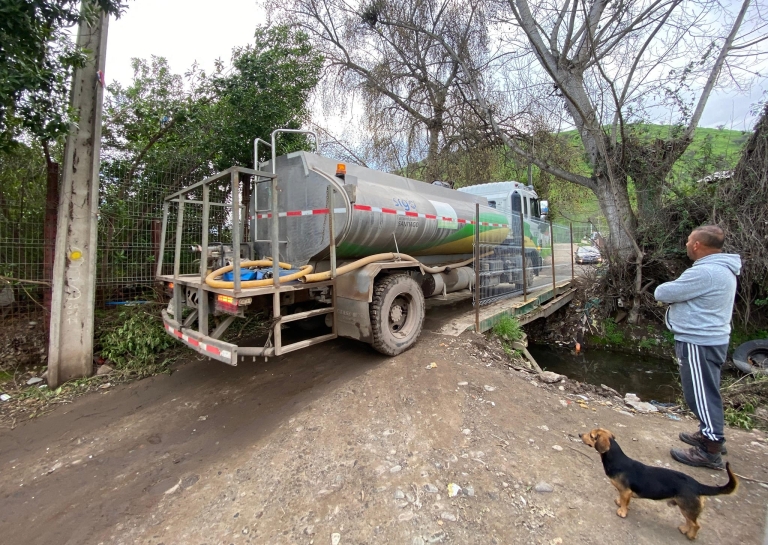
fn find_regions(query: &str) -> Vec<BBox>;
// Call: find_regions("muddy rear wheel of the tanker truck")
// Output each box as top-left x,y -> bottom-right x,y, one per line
371,274 -> 424,356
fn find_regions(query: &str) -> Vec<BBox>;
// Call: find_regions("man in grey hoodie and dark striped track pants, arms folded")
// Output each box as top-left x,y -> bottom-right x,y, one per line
654,225 -> 741,469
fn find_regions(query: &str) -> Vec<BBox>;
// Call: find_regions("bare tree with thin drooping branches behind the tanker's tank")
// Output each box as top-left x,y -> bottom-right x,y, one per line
275,0 -> 488,181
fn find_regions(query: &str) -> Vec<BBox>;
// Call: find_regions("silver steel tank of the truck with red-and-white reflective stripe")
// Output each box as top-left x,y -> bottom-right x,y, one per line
251,152 -> 509,266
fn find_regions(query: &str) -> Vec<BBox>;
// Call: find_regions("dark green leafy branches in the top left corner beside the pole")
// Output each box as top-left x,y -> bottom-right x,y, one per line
0,0 -> 125,149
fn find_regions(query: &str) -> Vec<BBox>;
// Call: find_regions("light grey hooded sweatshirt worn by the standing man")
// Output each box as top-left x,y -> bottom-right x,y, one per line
653,254 -> 741,346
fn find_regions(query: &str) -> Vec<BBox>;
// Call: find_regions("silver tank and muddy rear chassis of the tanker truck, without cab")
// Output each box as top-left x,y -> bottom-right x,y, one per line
157,131 -> 510,365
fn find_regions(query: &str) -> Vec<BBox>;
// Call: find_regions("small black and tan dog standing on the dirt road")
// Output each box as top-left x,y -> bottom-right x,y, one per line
580,428 -> 739,539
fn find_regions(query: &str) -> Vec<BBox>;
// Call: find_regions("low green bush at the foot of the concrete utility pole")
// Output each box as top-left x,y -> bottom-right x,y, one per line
99,305 -> 175,372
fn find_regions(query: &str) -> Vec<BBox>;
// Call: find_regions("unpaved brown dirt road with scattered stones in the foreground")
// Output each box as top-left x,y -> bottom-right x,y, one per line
0,320 -> 768,545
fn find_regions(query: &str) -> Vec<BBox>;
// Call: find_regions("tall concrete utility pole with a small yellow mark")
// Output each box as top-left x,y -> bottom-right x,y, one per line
48,4 -> 108,388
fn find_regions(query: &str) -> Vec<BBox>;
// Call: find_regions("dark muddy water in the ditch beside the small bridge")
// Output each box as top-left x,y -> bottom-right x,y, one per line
528,345 -> 681,402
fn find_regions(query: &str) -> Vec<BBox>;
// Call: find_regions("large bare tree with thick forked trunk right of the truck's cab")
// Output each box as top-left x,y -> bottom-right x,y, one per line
368,0 -> 768,321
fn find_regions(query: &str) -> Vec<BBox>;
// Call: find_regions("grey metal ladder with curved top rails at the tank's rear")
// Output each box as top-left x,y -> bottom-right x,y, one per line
252,129 -> 338,356
